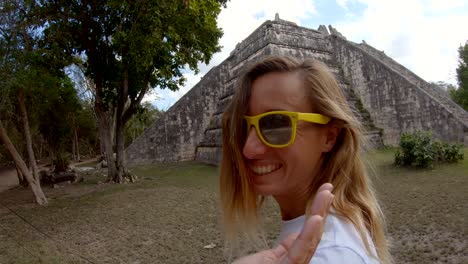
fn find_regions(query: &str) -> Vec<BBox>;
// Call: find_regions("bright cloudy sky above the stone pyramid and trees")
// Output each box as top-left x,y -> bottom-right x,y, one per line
144,0 -> 468,110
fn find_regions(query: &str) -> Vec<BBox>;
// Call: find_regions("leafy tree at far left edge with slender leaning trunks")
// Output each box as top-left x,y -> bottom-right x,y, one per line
0,0 -> 80,204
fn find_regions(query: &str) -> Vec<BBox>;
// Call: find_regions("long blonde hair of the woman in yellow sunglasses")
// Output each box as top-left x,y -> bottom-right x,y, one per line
220,56 -> 392,263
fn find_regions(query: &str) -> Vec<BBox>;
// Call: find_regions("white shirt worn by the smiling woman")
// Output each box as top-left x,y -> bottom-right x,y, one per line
277,214 -> 379,264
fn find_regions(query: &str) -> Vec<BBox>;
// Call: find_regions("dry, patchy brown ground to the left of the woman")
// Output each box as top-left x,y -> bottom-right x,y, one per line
0,166 -> 229,263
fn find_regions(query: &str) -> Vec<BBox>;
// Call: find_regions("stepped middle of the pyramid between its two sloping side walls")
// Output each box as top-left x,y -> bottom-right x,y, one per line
196,20 -> 383,164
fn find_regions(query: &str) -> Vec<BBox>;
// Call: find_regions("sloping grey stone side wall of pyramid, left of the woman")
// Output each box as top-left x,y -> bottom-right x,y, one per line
126,64 -> 228,164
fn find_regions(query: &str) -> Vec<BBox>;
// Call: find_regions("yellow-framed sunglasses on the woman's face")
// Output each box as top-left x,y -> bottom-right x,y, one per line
244,111 -> 331,148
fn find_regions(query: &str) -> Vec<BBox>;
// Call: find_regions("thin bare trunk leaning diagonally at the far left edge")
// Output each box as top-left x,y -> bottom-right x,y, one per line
0,120 -> 47,205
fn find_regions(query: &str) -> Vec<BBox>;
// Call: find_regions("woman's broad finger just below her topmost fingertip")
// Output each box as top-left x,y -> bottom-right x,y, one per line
282,215 -> 325,264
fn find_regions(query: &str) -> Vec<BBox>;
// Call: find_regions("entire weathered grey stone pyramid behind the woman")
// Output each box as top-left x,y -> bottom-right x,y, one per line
126,20 -> 468,164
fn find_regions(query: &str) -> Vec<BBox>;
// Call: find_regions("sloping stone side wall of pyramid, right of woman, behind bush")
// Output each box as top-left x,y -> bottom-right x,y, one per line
333,35 -> 468,145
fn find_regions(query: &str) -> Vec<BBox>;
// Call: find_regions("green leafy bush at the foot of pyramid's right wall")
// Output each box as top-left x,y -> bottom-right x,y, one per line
395,132 -> 464,168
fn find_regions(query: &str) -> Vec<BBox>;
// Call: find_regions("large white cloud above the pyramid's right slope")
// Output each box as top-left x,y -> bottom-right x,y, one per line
335,0 -> 468,83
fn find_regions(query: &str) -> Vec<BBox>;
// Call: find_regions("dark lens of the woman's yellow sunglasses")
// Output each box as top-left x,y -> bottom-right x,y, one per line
259,114 -> 292,145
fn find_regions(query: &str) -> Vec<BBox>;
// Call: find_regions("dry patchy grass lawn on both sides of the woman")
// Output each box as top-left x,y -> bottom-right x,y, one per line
0,149 -> 468,264
